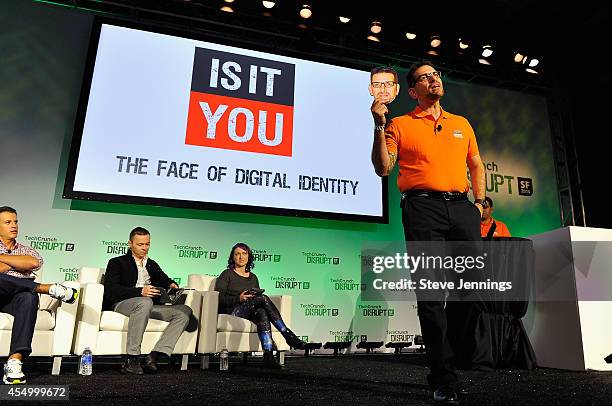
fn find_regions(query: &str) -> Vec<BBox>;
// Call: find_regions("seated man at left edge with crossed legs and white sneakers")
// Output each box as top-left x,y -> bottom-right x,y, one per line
0,206 -> 79,384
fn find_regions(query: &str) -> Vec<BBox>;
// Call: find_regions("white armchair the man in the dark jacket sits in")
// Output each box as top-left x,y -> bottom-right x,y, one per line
72,267 -> 202,370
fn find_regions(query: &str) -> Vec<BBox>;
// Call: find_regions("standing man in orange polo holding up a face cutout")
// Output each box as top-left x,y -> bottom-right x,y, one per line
371,62 -> 485,405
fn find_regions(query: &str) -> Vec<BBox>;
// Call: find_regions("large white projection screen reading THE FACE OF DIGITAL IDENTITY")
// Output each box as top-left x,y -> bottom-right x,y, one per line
67,24 -> 383,219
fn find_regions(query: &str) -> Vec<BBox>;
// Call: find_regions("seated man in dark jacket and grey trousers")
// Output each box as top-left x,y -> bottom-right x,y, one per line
103,227 -> 191,375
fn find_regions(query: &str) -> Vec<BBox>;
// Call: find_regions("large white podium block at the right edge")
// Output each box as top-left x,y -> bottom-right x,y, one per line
523,227 -> 612,371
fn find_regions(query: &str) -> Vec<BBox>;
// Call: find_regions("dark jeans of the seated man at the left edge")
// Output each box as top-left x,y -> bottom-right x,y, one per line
0,273 -> 38,357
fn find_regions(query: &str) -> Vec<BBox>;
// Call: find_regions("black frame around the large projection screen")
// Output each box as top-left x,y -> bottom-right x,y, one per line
62,16 -> 389,224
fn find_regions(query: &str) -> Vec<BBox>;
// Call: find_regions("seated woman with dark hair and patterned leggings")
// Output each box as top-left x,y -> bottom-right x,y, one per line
215,243 -> 304,368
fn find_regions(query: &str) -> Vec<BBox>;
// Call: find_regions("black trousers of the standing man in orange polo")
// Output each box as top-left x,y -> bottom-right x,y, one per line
401,196 -> 481,389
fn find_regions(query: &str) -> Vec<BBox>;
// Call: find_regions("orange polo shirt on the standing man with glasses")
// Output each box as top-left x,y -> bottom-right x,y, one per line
385,106 -> 480,192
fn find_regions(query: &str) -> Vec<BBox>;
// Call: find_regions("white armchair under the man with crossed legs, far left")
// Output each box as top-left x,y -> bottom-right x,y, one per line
0,273 -> 79,375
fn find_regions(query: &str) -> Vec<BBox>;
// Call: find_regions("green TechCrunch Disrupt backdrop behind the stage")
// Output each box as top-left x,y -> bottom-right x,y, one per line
0,0 -> 560,352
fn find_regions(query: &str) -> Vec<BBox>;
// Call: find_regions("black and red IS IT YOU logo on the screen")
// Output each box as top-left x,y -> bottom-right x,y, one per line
185,48 -> 295,156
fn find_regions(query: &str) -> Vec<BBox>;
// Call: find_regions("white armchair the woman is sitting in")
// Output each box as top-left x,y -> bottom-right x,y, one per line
187,274 -> 292,369
